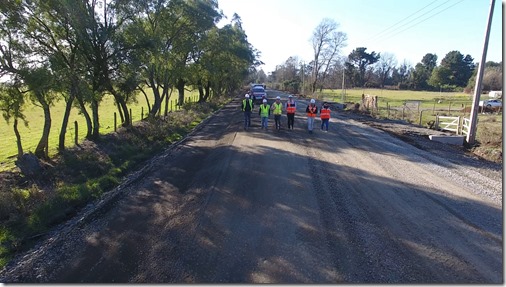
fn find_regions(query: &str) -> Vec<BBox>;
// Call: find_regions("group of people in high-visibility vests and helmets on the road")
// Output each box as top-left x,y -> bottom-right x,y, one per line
241,94 -> 331,133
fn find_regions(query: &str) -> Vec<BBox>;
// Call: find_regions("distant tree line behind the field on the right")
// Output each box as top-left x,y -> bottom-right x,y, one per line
264,19 -> 502,93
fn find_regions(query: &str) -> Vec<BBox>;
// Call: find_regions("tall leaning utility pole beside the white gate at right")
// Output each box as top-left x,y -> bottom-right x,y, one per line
466,0 -> 495,145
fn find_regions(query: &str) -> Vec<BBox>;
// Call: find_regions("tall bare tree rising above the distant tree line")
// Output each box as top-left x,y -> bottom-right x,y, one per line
311,18 -> 347,92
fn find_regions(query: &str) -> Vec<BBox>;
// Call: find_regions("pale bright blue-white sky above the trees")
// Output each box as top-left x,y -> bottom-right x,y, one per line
218,0 -> 504,74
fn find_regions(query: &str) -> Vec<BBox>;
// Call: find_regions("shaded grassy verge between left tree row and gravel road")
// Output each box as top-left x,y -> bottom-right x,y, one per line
0,98 -> 230,268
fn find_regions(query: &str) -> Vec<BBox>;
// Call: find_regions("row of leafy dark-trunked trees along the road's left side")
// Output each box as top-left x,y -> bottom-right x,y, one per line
0,0 -> 261,160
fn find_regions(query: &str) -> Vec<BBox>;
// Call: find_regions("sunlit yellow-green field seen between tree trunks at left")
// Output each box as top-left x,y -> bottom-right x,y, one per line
0,91 -> 198,171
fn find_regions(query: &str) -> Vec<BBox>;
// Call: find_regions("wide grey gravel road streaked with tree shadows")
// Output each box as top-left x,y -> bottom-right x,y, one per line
0,92 -> 503,283
